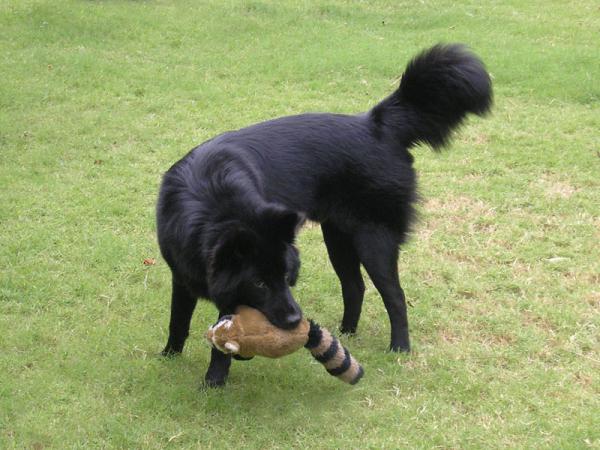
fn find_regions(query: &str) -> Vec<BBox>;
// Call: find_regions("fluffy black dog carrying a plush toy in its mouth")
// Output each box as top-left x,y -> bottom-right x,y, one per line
157,45 -> 492,385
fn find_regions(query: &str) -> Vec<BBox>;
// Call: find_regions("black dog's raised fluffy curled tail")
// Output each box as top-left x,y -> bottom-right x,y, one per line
370,44 -> 492,150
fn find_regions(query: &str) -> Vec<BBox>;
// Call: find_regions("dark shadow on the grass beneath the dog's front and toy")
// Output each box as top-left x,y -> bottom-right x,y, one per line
121,351 -> 361,431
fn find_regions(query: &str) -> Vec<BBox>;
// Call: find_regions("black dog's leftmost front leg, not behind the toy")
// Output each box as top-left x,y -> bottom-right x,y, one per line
161,278 -> 198,356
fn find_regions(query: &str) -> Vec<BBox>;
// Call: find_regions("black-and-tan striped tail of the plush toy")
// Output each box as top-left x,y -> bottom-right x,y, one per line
304,320 -> 364,384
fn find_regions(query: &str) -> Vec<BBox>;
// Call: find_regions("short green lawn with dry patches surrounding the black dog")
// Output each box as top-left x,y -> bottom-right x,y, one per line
0,0 -> 600,449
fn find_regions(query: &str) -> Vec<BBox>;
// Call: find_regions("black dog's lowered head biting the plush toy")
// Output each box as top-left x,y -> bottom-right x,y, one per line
208,205 -> 304,329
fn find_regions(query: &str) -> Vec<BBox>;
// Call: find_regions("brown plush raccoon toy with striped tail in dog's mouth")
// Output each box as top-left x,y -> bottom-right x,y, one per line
206,306 -> 364,384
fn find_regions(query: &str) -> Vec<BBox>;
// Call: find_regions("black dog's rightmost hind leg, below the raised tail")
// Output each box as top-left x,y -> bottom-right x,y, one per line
354,229 -> 410,352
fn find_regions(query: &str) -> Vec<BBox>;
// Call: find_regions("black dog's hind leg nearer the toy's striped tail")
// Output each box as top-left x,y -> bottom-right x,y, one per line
321,222 -> 365,333
